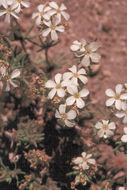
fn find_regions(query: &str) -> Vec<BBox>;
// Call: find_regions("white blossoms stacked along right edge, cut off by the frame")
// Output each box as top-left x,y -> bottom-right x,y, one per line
105,84 -> 127,142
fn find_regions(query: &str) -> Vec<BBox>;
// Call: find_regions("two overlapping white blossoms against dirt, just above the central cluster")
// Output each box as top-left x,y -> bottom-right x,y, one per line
70,39 -> 101,67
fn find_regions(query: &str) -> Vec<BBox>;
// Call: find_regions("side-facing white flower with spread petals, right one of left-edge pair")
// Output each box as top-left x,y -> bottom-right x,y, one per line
5,69 -> 20,91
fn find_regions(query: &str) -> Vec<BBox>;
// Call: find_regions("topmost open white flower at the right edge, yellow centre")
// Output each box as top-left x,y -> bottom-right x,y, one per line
105,84 -> 127,110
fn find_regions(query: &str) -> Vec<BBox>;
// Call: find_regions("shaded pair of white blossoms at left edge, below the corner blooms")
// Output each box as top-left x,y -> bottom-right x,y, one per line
0,65 -> 21,92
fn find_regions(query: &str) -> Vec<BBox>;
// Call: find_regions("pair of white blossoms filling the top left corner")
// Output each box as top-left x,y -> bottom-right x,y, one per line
0,0 -> 30,23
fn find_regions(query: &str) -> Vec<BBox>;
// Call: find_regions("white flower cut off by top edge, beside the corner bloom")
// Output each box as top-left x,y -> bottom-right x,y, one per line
14,0 -> 30,13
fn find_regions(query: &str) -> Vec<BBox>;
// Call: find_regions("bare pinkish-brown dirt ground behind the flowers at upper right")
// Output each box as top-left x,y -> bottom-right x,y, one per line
29,0 -> 127,105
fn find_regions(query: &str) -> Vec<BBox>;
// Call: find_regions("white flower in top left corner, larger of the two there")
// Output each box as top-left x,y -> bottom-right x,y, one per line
0,0 -> 19,23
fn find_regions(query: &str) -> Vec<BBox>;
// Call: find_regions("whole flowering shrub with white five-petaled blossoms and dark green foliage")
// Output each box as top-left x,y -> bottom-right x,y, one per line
0,0 -> 127,190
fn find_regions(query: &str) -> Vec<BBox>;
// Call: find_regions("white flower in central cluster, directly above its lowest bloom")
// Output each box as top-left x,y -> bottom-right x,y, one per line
66,87 -> 89,108
